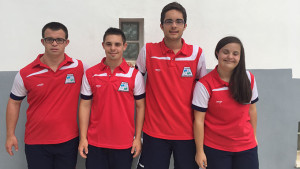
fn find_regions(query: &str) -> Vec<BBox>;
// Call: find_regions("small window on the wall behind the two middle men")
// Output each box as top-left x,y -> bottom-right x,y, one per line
119,18 -> 144,62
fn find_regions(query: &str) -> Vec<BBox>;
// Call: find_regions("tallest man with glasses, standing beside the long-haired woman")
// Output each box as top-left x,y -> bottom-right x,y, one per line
137,2 -> 206,169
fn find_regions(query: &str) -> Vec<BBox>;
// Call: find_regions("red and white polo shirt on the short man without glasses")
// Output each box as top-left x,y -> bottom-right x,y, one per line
81,58 -> 145,149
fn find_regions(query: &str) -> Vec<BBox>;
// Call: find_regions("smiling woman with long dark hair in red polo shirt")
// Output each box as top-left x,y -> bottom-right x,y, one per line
192,36 -> 258,169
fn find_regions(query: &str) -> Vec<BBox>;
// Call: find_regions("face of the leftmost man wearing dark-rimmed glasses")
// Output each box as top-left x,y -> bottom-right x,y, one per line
41,29 -> 69,56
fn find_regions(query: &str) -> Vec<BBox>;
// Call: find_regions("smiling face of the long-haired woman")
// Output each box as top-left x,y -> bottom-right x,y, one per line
217,43 -> 241,71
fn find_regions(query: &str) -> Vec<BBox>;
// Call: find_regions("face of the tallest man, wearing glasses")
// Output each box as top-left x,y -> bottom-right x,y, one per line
160,9 -> 187,40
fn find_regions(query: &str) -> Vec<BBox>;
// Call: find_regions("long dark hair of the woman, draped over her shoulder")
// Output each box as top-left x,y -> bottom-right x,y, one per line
215,36 -> 252,104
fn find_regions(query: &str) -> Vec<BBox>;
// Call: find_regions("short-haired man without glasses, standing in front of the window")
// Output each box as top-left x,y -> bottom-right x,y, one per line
78,28 -> 145,169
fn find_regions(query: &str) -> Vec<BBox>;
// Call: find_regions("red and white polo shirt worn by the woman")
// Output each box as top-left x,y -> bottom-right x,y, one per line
192,67 -> 258,152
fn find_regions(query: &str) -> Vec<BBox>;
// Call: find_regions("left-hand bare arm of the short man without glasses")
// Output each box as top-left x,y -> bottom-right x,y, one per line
78,99 -> 92,158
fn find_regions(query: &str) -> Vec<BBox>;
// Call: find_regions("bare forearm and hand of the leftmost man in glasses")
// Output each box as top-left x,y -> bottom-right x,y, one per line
5,98 -> 22,156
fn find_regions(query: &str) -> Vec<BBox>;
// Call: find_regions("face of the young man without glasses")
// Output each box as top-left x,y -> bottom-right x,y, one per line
102,35 -> 127,61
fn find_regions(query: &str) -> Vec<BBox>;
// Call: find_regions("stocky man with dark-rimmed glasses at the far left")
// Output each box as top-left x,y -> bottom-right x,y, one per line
6,22 -> 84,169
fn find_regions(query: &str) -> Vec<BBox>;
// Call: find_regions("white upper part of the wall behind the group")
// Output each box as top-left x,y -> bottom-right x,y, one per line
0,0 -> 300,78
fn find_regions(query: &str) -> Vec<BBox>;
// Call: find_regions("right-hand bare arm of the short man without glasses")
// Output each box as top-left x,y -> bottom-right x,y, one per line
131,98 -> 145,158
